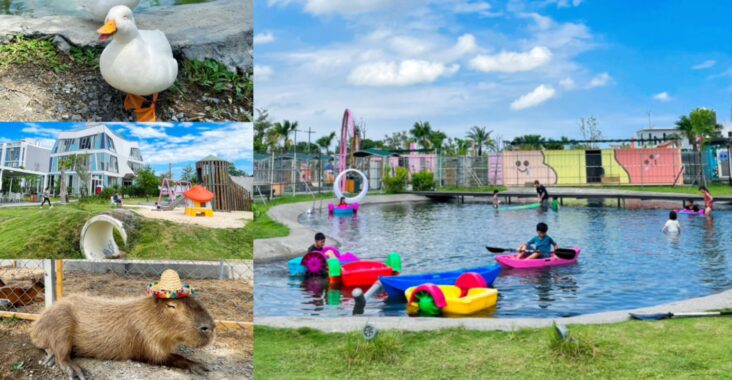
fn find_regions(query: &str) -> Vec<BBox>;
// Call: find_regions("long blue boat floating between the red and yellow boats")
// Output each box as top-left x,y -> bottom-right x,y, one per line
379,265 -> 501,302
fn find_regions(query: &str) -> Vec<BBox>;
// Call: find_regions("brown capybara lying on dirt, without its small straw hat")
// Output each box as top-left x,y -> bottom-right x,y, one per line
31,294 -> 215,380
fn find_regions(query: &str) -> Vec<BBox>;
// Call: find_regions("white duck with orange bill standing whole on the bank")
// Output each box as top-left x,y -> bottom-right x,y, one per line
97,5 -> 178,121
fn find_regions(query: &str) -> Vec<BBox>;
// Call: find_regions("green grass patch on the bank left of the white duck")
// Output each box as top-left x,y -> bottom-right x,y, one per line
0,34 -> 69,73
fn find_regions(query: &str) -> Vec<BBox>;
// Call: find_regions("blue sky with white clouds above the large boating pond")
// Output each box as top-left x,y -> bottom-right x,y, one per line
254,0 -> 732,139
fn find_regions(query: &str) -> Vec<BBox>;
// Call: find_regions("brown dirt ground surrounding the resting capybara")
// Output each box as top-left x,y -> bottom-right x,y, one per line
0,271 -> 254,380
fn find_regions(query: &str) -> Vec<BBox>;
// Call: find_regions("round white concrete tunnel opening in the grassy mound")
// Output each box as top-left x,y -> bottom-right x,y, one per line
79,215 -> 127,260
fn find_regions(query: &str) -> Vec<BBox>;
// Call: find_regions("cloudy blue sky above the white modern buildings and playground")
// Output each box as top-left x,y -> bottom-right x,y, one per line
0,123 -> 252,178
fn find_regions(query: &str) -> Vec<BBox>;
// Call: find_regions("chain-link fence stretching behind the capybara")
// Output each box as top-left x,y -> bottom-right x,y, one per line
0,260 -> 254,336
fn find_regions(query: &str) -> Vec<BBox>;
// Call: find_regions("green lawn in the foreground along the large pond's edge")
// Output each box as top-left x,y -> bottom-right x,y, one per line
254,317 -> 732,379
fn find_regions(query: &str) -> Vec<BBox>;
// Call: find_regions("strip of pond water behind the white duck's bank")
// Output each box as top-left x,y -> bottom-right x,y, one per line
0,0 -> 214,17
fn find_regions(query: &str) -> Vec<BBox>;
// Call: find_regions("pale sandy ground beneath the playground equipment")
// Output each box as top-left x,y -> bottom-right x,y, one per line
125,205 -> 254,228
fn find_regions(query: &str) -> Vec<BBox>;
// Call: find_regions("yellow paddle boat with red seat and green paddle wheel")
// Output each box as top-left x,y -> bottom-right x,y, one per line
404,272 -> 498,316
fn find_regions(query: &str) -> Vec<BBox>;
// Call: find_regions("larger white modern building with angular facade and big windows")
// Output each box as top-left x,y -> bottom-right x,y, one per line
49,124 -> 143,194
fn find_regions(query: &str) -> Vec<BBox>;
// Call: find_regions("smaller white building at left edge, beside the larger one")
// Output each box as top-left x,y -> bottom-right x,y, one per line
0,140 -> 51,196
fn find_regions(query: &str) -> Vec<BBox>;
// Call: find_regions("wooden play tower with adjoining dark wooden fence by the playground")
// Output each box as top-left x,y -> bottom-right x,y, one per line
196,155 -> 252,211
